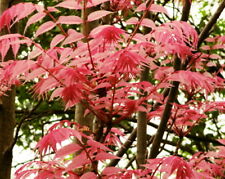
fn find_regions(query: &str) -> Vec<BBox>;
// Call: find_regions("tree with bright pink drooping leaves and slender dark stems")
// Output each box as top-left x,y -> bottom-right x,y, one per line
0,0 -> 225,178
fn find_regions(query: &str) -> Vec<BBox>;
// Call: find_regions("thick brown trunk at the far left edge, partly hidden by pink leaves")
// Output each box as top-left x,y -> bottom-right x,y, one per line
0,0 -> 15,179
